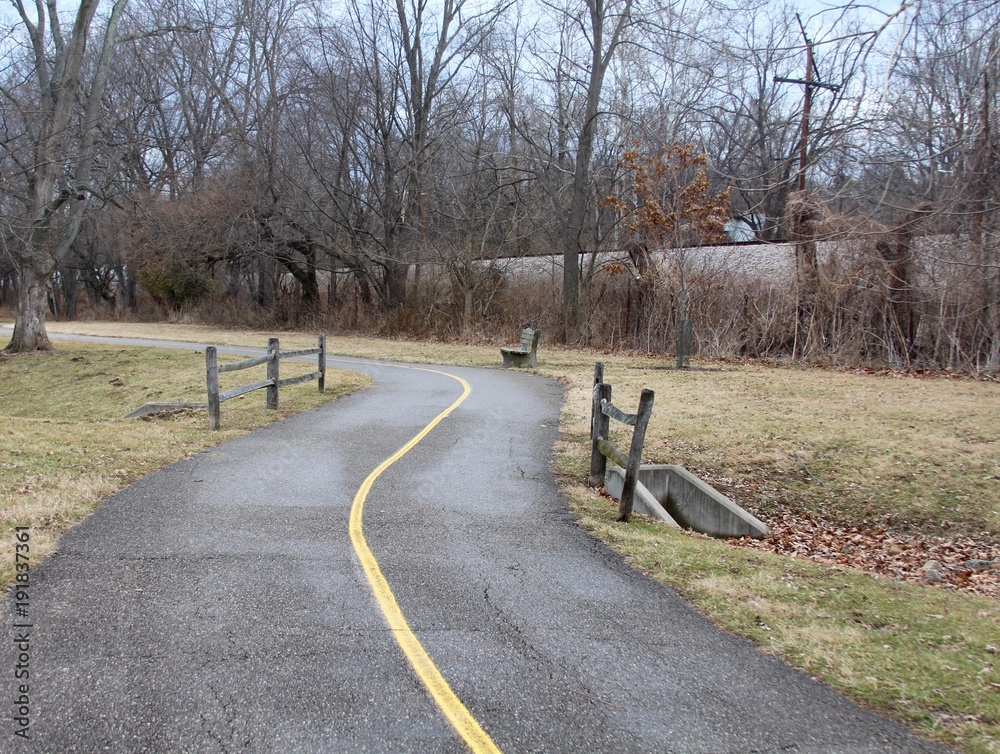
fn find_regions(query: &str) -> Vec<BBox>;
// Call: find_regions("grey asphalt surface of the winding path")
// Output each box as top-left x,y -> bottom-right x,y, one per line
0,336 -> 943,754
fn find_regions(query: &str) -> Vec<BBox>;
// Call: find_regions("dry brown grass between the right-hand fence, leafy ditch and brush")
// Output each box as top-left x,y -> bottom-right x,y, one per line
564,363 -> 1000,540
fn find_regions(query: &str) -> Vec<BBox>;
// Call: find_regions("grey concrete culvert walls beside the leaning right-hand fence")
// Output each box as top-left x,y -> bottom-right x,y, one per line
604,464 -> 768,539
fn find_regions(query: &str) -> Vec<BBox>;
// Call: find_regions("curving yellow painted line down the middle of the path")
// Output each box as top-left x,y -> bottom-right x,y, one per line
349,367 -> 500,754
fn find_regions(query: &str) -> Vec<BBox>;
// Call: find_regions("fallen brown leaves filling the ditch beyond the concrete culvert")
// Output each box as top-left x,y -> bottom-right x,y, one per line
729,508 -> 1000,600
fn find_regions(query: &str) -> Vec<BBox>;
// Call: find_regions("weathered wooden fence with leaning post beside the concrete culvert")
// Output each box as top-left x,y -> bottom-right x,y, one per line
588,362 -> 654,522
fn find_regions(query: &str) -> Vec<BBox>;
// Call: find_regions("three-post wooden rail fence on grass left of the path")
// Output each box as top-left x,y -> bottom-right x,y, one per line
205,334 -> 326,429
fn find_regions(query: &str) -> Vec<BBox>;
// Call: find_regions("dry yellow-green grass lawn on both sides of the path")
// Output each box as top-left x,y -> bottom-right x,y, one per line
0,323 -> 1000,754
